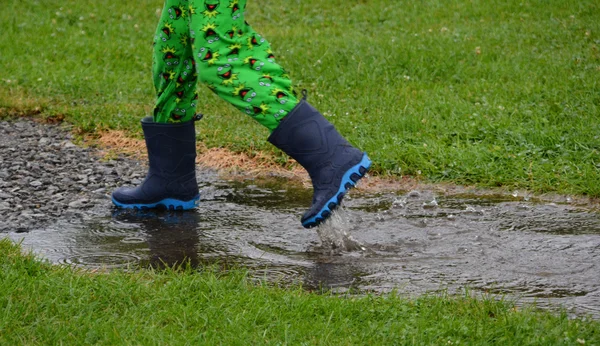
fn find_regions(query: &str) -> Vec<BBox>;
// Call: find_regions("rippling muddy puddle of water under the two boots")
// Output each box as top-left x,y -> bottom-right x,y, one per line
5,173 -> 600,318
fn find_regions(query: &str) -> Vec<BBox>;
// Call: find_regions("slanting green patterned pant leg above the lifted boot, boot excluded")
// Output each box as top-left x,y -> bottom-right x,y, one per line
189,0 -> 298,131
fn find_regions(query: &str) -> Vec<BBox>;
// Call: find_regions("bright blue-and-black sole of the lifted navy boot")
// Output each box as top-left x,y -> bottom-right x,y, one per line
302,153 -> 371,228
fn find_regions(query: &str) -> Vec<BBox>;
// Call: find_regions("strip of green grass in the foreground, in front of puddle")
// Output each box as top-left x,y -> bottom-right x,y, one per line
0,240 -> 600,345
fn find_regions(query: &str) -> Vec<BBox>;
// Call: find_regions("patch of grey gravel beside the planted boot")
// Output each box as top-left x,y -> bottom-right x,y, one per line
0,119 -> 147,232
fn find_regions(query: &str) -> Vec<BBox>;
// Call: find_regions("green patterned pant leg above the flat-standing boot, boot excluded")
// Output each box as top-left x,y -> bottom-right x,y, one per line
152,0 -> 198,123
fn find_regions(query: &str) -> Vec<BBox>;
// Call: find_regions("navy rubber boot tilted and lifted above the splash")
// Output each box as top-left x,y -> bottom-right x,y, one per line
269,99 -> 371,228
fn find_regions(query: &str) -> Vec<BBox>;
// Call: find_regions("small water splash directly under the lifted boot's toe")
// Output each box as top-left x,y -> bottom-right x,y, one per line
317,206 -> 366,254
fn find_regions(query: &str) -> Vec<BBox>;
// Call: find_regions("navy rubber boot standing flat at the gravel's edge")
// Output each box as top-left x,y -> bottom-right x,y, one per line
112,117 -> 200,210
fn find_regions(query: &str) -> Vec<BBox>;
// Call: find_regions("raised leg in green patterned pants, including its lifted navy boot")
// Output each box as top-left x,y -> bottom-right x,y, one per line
184,0 -> 371,227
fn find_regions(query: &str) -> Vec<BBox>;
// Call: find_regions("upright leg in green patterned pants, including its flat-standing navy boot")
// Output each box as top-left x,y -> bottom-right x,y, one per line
112,0 -> 200,210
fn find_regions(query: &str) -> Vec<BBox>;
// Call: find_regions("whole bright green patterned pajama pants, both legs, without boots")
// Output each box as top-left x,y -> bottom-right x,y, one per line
152,0 -> 298,131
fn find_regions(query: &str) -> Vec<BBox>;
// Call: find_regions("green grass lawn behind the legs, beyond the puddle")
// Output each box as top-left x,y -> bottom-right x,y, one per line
0,0 -> 600,197
